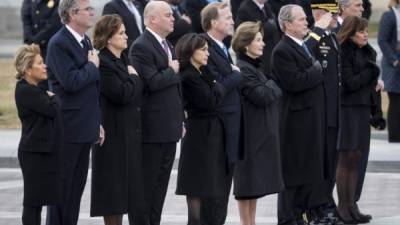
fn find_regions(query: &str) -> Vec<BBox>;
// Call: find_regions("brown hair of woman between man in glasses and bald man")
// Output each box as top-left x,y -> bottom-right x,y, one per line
93,14 -> 123,50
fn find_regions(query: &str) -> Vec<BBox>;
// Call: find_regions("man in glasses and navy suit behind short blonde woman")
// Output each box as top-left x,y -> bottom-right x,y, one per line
46,0 -> 104,225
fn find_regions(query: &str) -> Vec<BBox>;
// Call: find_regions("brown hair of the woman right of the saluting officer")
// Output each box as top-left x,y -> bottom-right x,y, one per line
337,16 -> 368,44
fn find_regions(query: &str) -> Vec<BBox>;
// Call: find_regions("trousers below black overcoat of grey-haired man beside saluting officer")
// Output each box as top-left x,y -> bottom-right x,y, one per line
278,184 -> 310,225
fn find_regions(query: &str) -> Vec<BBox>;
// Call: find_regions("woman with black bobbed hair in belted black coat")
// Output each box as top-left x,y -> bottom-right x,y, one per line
176,33 -> 231,225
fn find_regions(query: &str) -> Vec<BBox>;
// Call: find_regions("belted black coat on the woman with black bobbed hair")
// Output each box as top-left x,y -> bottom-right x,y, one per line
176,66 -> 231,198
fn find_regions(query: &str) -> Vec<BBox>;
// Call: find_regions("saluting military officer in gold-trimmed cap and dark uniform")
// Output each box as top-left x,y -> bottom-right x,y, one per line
305,0 -> 341,224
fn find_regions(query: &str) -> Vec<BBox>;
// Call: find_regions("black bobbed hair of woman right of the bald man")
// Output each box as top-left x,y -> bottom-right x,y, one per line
175,33 -> 207,68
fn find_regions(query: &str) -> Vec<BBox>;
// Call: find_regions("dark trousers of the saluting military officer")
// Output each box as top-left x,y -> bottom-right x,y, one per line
306,127 -> 339,209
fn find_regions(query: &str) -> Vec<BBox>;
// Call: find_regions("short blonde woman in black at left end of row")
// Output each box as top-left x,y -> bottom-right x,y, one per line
14,44 -> 63,225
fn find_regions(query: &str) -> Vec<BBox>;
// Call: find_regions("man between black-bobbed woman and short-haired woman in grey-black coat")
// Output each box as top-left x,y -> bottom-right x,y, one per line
201,2 -> 243,225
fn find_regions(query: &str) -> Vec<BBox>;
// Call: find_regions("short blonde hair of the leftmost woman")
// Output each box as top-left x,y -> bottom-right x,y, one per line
14,44 -> 40,80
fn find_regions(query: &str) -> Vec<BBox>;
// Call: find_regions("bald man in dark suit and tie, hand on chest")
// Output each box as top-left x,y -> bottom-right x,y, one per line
129,1 -> 183,225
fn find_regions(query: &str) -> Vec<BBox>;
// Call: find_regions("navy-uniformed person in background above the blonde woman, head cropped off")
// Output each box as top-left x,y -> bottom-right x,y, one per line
21,0 -> 61,58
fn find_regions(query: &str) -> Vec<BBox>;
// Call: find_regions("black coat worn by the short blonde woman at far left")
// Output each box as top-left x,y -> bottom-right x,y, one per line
15,79 -> 63,206
